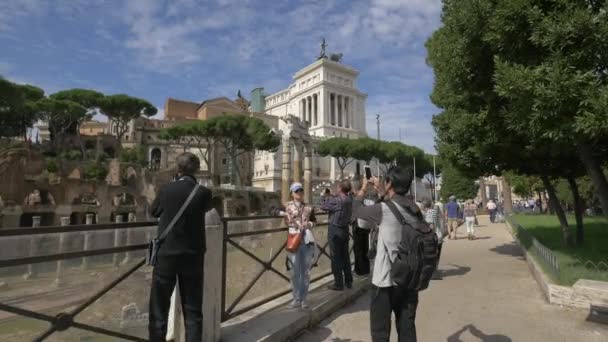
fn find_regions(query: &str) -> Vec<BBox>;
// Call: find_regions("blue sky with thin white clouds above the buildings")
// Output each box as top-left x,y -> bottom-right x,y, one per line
0,0 -> 441,152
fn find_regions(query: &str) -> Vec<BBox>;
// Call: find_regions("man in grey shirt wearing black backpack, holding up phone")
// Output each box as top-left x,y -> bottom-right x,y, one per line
353,166 -> 437,342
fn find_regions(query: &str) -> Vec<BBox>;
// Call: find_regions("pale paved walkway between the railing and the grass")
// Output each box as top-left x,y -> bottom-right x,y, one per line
298,217 -> 608,342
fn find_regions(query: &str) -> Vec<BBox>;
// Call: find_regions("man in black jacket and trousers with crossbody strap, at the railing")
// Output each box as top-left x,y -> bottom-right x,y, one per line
148,153 -> 211,342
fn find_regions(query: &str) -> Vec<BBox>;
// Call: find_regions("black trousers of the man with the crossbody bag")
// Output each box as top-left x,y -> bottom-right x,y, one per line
148,255 -> 204,342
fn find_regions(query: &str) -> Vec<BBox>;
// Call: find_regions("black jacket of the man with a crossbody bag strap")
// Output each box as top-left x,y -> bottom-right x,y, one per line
150,176 -> 212,256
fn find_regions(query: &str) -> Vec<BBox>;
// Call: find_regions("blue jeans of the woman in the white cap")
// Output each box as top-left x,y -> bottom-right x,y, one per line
289,242 -> 315,302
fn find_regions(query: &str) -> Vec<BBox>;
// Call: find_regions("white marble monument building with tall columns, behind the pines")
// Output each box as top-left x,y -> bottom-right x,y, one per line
253,59 -> 367,192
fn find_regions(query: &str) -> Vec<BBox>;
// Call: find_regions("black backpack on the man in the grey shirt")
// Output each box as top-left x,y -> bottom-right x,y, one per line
385,201 -> 439,291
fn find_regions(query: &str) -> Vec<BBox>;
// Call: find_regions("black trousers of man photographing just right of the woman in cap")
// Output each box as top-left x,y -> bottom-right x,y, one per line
327,226 -> 353,287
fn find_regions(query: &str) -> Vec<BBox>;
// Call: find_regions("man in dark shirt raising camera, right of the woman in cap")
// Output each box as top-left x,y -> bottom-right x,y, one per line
321,180 -> 353,291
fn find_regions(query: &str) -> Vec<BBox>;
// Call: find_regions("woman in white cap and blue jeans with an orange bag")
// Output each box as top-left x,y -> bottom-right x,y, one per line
284,183 -> 316,309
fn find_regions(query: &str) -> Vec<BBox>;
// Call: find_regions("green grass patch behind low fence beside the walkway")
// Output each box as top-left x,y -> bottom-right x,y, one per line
513,215 -> 608,286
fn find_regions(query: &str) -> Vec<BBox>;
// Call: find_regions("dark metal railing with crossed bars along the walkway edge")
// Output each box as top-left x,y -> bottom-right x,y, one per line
0,213 -> 352,341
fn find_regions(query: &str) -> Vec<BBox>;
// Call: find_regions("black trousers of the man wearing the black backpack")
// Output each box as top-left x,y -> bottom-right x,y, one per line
369,285 -> 418,342
